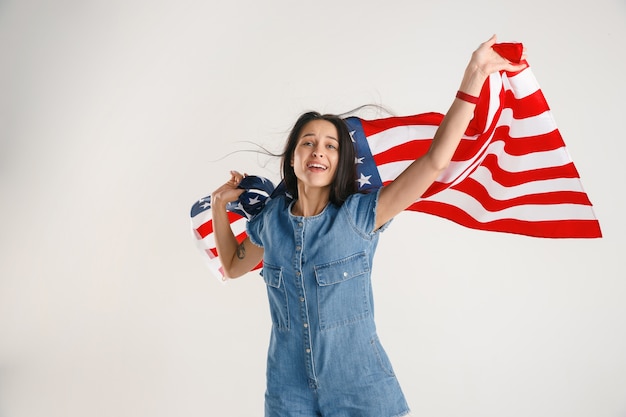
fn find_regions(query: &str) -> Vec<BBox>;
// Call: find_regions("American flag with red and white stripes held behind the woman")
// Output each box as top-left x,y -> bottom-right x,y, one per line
191,44 -> 602,277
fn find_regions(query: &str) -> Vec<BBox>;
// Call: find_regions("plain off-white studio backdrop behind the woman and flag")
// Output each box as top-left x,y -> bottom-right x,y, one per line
0,0 -> 626,417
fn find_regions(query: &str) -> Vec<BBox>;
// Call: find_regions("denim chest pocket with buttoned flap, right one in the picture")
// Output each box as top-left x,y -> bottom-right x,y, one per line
314,252 -> 372,330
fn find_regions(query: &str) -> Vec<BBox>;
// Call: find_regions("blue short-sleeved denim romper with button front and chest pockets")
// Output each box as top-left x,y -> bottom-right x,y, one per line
247,192 -> 409,417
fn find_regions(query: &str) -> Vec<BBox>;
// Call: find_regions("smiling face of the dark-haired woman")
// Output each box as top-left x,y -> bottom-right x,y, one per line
291,119 -> 339,188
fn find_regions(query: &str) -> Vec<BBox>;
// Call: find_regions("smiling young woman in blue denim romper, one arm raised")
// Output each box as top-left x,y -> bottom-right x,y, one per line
211,36 -> 525,417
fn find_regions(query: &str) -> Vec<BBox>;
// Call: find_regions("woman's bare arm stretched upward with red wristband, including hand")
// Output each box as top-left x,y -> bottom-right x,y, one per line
376,35 -> 526,228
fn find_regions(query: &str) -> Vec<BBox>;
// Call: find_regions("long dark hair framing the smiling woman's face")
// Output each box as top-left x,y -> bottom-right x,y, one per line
281,111 -> 358,206
